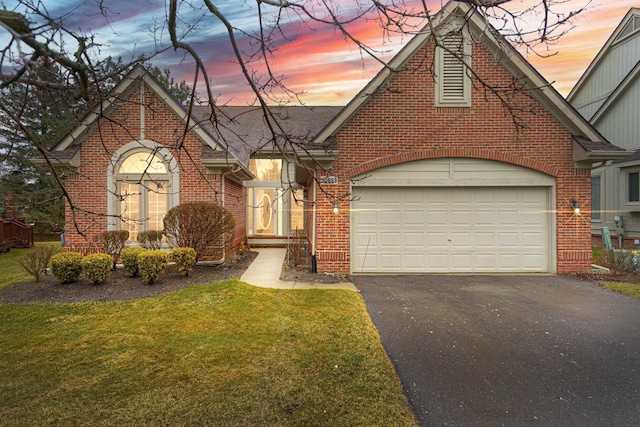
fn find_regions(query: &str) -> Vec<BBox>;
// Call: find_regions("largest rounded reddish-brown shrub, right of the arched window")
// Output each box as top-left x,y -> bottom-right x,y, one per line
163,202 -> 236,262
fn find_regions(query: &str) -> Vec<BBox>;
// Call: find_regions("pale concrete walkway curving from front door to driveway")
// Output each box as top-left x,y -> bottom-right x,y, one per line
240,248 -> 357,291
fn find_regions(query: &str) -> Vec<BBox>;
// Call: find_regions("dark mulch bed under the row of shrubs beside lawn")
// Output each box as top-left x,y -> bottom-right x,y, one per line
0,252 -> 258,303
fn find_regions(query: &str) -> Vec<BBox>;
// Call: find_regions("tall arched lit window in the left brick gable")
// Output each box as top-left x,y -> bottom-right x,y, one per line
114,150 -> 172,241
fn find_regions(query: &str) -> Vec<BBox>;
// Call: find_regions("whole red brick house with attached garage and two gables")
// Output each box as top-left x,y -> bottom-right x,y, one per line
52,2 -> 628,274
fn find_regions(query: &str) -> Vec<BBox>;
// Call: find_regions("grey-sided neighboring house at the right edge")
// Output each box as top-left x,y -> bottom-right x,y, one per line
567,8 -> 640,238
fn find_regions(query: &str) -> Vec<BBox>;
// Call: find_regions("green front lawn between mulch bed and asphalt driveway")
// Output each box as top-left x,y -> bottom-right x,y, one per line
0,280 -> 416,426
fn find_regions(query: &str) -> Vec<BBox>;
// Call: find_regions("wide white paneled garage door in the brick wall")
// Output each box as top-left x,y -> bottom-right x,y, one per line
352,187 -> 550,273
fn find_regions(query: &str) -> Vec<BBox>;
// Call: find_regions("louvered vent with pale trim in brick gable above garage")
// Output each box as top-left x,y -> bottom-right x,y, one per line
435,30 -> 471,107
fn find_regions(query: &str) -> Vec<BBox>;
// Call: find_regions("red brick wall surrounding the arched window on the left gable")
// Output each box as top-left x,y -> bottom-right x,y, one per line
65,82 -> 246,256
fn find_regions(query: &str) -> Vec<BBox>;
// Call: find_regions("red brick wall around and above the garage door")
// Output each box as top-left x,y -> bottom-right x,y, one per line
316,39 -> 591,273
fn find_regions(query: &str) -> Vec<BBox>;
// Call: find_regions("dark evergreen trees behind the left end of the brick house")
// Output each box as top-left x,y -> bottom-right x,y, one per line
0,58 -> 190,234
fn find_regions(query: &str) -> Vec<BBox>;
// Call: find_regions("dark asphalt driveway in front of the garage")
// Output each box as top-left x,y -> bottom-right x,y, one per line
354,276 -> 640,426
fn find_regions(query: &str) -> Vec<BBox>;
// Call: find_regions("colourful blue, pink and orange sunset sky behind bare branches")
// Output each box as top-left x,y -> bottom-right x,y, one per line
0,0 -> 639,105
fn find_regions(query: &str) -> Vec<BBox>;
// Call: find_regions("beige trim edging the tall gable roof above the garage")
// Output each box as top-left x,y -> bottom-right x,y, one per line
315,0 -> 630,162
